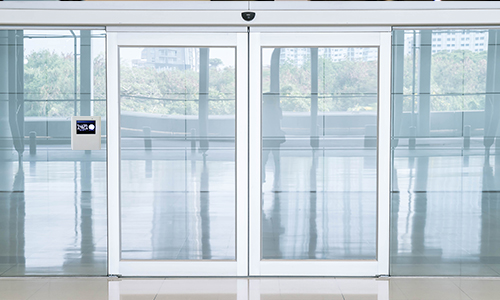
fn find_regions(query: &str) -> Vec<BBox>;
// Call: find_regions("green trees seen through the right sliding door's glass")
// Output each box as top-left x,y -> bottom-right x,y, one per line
263,57 -> 378,112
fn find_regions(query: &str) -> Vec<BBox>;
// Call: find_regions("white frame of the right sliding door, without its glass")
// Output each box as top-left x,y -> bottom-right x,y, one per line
249,28 -> 391,276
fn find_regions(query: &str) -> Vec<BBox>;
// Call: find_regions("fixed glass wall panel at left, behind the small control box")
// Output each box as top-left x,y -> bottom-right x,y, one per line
0,30 -> 107,276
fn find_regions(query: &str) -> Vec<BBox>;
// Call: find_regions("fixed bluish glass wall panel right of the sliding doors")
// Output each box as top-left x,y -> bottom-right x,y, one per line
390,29 -> 500,276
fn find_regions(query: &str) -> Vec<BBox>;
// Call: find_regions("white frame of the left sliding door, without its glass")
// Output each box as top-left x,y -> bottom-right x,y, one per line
107,27 -> 248,276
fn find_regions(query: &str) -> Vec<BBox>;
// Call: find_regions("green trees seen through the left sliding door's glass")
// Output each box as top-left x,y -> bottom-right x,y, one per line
120,61 -> 236,115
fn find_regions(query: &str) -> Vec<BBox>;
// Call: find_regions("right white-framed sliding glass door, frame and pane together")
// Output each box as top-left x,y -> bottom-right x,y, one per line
250,30 -> 390,276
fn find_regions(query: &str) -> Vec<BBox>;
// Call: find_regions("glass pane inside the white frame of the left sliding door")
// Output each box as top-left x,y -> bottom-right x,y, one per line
120,47 -> 236,260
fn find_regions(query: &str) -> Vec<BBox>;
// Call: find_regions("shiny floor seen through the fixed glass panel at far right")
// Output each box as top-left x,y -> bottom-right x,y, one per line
390,151 -> 500,276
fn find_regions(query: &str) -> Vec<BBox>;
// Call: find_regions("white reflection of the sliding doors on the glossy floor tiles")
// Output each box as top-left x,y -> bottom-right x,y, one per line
108,278 -> 388,300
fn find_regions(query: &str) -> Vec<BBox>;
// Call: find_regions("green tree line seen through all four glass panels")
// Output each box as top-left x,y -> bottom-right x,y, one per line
24,50 -> 487,117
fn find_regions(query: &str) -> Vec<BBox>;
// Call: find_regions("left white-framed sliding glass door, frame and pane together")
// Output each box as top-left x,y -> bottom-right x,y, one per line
108,29 -> 248,276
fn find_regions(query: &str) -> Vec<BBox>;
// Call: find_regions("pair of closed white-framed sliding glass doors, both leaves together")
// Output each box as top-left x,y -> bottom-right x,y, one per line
108,28 -> 391,276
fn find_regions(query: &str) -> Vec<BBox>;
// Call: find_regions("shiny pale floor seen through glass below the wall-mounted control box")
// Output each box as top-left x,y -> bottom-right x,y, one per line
0,161 -> 107,276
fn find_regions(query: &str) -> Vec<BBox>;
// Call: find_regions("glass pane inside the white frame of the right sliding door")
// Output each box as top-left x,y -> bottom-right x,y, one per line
261,48 -> 378,259
